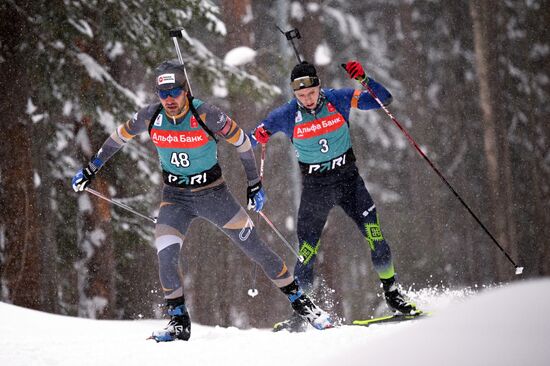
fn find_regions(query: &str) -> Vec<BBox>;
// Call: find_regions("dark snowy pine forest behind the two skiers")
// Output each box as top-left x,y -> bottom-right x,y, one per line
0,0 -> 550,328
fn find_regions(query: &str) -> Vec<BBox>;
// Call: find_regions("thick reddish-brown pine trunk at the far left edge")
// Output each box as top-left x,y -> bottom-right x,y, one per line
0,1 -> 42,309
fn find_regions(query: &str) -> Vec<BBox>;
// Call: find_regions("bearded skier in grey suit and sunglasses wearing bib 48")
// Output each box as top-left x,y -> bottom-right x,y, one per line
72,61 -> 332,341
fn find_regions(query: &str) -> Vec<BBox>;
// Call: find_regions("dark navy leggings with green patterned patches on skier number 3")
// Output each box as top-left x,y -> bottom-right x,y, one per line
294,164 -> 394,290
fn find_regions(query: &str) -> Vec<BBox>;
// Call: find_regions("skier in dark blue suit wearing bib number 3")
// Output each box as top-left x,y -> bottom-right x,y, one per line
250,61 -> 417,331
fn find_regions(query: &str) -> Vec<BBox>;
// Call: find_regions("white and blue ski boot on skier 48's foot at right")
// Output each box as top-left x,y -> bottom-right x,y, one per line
281,281 -> 334,330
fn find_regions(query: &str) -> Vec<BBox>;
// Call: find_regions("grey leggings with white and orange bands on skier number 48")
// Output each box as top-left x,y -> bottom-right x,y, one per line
155,183 -> 293,299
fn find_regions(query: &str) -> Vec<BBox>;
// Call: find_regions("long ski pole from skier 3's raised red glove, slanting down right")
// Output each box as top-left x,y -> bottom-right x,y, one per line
342,64 -> 523,275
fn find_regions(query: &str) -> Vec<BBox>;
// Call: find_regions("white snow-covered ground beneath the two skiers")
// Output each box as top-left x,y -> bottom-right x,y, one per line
0,278 -> 550,366
